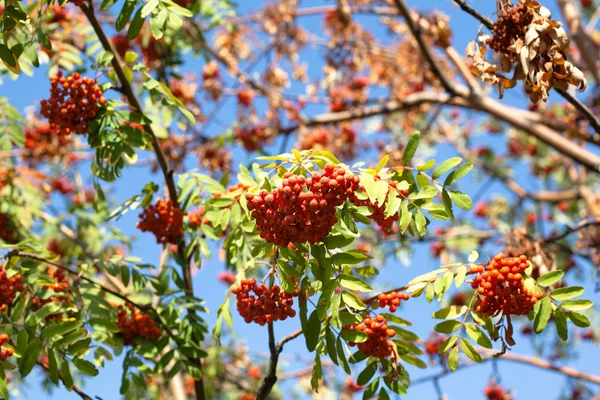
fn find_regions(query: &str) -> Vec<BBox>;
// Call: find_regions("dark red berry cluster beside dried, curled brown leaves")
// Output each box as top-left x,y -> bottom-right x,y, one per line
487,4 -> 533,61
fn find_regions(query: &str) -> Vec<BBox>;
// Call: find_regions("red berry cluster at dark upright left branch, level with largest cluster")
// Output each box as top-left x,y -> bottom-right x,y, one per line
137,200 -> 183,244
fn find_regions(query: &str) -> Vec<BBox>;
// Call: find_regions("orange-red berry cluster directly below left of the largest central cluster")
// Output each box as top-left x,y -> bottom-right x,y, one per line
231,278 -> 298,326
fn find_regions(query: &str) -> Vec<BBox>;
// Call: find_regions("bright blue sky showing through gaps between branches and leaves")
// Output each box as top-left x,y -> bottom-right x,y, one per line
0,0 -> 600,400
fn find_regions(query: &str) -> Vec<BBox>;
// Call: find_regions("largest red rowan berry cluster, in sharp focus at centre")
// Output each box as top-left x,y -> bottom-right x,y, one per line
246,164 -> 358,246
